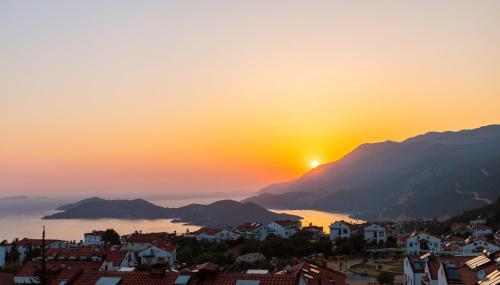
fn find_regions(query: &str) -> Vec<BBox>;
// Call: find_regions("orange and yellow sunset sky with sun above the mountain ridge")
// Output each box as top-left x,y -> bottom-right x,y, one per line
0,0 -> 500,196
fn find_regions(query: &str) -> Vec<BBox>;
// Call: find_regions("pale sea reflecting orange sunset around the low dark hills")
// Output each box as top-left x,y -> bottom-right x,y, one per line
0,196 -> 362,242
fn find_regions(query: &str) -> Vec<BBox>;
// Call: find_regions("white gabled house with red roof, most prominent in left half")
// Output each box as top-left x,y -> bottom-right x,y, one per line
138,241 -> 176,266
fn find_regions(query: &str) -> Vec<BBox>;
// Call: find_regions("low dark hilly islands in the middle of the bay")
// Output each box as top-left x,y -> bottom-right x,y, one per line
43,197 -> 300,227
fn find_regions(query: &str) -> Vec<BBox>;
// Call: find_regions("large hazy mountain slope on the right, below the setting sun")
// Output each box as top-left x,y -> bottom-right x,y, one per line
243,125 -> 500,219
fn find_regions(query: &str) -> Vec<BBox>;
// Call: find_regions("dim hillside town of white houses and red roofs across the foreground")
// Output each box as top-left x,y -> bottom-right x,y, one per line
0,213 -> 500,285
